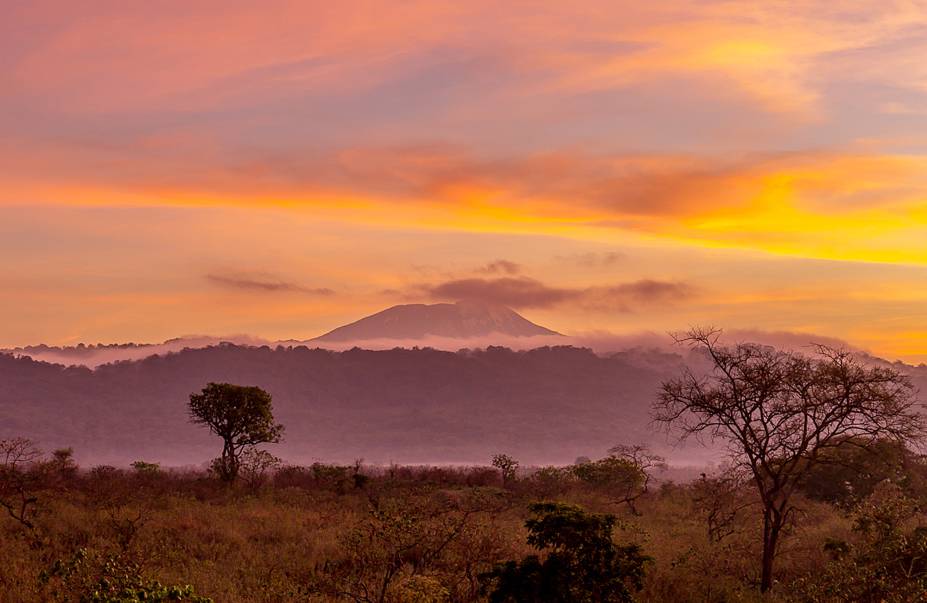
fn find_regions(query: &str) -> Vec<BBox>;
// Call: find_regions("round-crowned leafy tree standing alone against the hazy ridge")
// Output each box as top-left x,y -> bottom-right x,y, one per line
190,383 -> 283,482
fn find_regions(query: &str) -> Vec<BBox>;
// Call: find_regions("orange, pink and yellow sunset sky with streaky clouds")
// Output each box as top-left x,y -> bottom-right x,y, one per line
0,0 -> 927,362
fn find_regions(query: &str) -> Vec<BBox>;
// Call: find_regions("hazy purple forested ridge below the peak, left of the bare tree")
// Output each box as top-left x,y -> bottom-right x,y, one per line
0,345 -> 712,464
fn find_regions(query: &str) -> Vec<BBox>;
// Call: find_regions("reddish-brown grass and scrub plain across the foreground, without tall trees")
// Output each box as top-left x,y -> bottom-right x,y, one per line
0,445 -> 927,603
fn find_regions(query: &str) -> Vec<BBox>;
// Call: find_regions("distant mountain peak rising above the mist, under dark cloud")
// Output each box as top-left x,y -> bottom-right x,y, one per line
313,301 -> 560,341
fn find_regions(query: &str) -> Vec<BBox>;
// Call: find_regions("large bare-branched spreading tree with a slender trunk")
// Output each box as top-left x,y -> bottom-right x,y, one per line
654,329 -> 925,592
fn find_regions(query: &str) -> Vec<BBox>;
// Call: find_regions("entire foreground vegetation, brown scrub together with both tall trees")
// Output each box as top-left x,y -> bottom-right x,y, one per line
0,330 -> 927,603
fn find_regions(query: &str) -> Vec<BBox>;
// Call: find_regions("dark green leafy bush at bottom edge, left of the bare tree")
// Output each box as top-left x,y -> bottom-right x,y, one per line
484,503 -> 649,603
